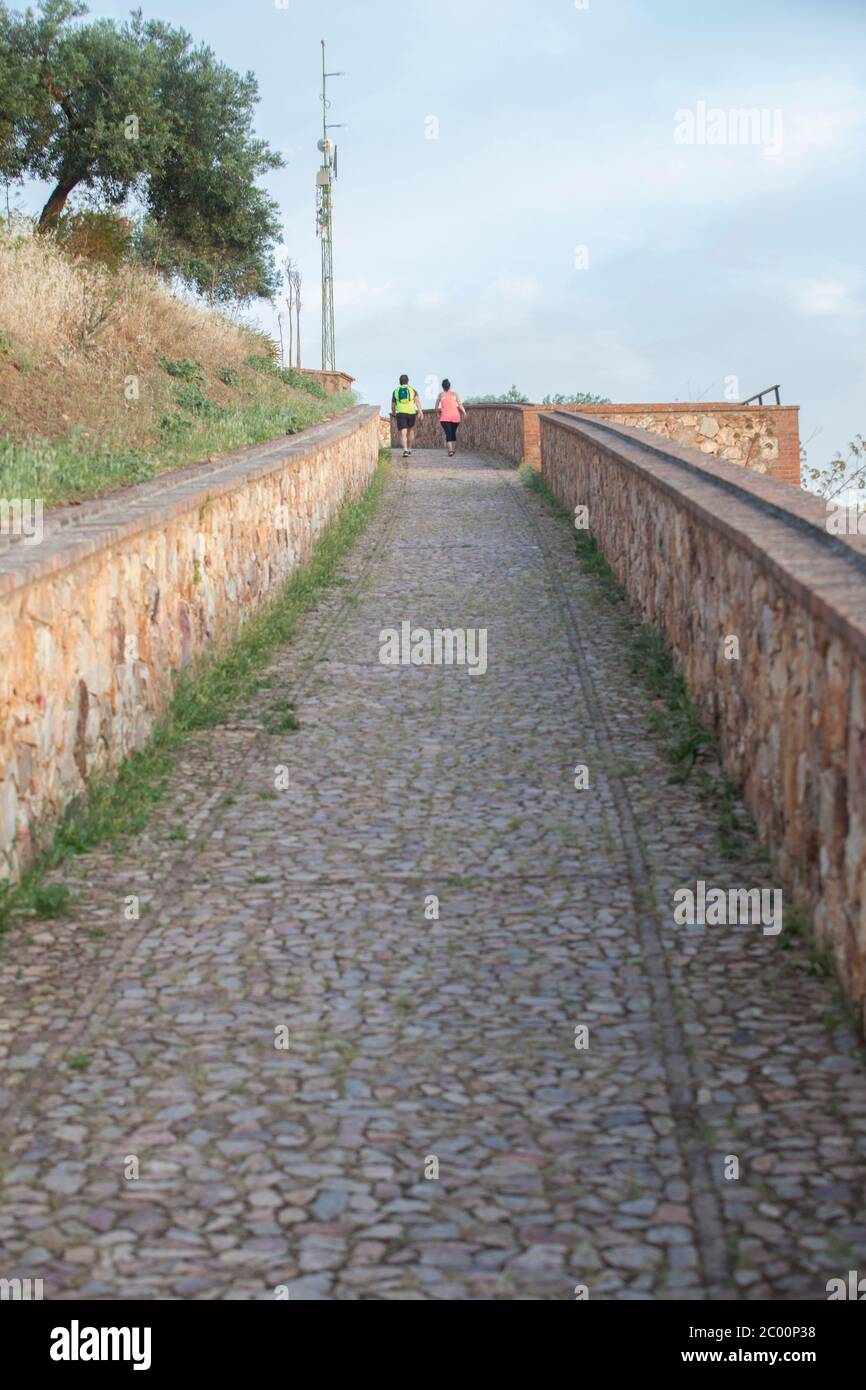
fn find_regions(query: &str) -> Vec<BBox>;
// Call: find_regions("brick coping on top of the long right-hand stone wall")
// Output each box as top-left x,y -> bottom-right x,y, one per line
545,411 -> 866,656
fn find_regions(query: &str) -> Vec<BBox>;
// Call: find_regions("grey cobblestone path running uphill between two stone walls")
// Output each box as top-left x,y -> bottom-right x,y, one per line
0,452 -> 866,1300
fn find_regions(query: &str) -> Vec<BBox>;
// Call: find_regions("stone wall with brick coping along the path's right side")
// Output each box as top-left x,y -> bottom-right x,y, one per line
541,413 -> 866,1015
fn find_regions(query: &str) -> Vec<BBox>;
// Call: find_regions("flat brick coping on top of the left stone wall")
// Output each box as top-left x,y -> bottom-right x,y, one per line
0,406 -> 379,596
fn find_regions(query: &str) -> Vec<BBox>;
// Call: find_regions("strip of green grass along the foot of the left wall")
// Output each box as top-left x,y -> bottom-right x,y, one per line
0,450 -> 391,942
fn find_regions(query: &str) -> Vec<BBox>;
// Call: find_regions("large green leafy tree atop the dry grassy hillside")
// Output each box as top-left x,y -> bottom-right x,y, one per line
0,0 -> 284,299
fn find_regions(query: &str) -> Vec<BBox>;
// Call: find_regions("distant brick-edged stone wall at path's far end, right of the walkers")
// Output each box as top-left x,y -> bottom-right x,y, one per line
391,400 -> 799,485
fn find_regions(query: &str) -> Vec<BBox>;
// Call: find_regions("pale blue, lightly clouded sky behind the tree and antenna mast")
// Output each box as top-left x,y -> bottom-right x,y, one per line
11,0 -> 866,466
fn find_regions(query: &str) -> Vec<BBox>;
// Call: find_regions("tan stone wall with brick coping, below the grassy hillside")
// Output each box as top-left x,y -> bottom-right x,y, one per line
0,406 -> 378,876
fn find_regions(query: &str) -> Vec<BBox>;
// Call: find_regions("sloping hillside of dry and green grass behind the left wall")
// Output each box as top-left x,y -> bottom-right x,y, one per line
0,225 -> 352,506
